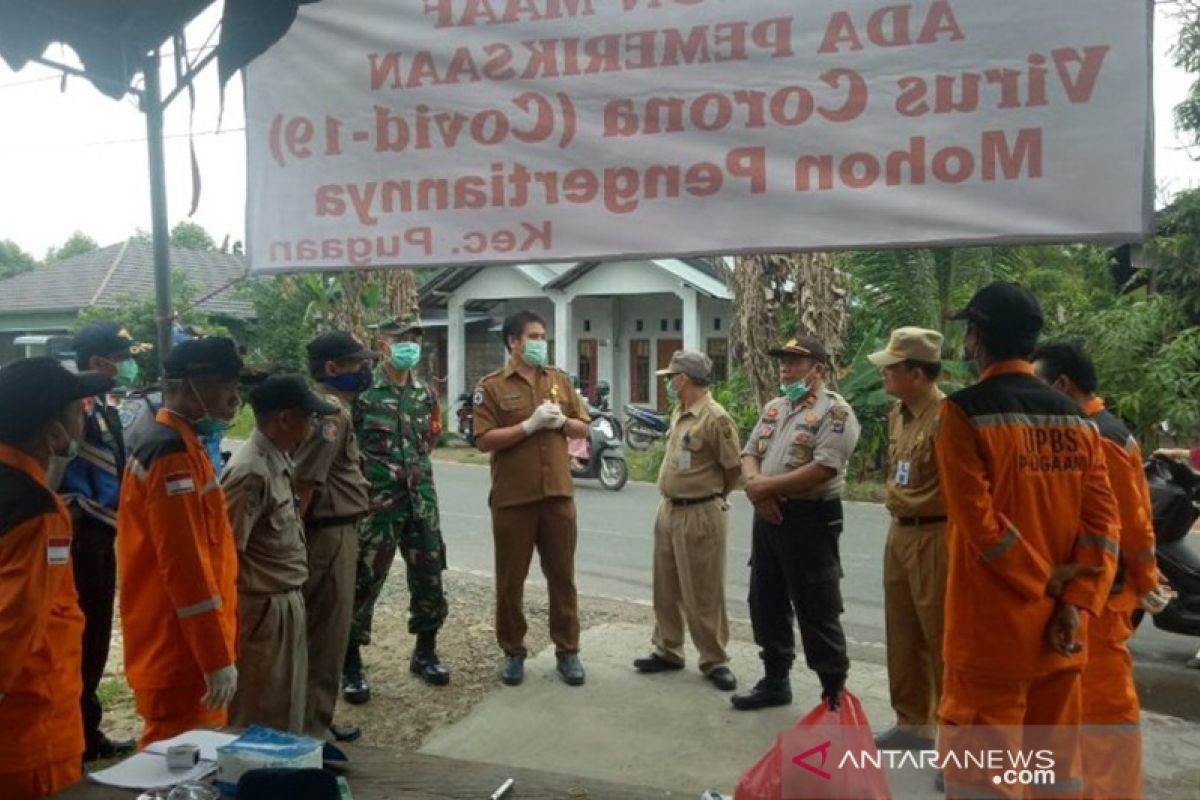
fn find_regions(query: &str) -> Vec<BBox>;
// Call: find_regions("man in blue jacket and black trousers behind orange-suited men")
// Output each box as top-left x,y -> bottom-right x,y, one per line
59,321 -> 145,762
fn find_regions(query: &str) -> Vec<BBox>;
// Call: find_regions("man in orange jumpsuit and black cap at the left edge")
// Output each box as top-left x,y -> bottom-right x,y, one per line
0,359 -> 113,800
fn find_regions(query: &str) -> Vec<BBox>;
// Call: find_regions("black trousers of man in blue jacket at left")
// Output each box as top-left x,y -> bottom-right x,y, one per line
71,516 -> 116,750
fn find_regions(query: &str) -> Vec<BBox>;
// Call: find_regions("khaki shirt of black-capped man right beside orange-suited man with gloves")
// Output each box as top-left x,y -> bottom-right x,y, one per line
221,431 -> 308,595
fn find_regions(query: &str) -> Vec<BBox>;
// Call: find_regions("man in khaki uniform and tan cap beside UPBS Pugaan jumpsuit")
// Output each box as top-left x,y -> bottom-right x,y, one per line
868,327 -> 947,750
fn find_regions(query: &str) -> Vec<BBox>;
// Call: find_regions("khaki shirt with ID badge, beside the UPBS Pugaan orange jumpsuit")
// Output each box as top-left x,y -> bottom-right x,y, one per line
887,386 -> 946,517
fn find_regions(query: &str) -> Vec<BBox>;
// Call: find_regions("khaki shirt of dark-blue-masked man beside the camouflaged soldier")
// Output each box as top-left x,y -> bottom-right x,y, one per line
295,386 -> 371,519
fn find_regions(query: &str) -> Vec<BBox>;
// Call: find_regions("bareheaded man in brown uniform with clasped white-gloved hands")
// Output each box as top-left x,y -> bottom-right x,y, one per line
474,311 -> 588,686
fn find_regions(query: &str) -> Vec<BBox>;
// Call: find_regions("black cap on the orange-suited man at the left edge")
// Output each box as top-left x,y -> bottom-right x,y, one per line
0,357 -> 113,441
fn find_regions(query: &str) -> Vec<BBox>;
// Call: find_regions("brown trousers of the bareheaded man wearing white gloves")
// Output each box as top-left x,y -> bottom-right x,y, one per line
492,498 -> 580,656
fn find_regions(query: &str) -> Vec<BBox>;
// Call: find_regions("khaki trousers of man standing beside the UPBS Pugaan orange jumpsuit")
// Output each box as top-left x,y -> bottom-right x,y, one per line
883,522 -> 947,738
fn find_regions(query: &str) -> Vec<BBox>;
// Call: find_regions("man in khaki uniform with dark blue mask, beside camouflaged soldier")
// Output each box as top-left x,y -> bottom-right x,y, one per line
295,331 -> 379,741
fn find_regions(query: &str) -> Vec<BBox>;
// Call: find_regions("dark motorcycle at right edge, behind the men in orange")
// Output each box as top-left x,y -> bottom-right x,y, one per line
1133,458 -> 1200,636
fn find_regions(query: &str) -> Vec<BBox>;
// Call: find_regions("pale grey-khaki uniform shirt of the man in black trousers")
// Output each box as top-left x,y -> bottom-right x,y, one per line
742,387 -> 860,500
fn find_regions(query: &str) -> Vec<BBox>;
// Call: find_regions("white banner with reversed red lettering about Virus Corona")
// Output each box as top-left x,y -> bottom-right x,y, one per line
246,0 -> 1153,272
